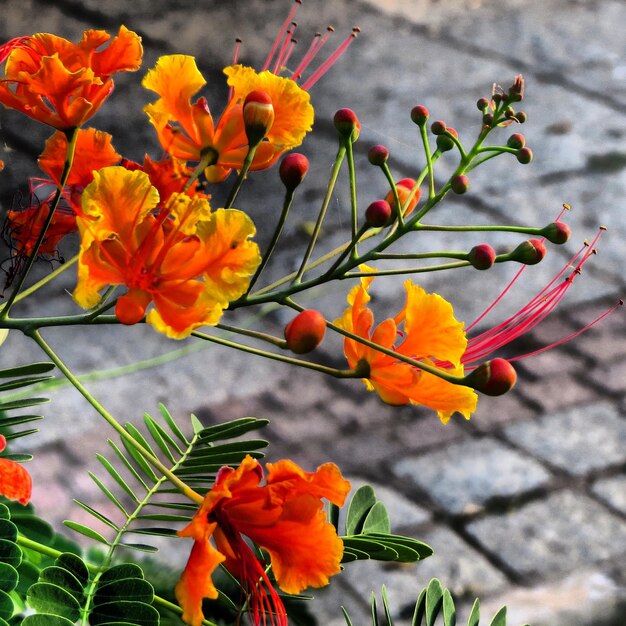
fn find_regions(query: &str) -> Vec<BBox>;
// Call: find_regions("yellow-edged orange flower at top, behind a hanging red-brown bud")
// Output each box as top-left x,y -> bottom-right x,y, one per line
143,54 -> 313,182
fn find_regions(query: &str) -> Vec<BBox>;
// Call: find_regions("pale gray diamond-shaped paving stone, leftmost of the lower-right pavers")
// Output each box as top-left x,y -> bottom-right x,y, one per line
392,438 -> 550,514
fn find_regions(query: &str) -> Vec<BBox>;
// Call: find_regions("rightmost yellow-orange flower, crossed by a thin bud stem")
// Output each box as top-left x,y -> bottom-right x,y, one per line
336,268 -> 477,424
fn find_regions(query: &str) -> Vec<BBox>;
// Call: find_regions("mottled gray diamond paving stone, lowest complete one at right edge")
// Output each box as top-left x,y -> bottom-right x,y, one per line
466,491 -> 626,580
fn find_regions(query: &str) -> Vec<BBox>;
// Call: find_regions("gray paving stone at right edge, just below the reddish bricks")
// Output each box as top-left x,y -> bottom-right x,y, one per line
503,402 -> 626,476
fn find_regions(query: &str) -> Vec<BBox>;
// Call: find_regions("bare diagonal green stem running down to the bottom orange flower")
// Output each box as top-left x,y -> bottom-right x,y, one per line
24,329 -> 204,504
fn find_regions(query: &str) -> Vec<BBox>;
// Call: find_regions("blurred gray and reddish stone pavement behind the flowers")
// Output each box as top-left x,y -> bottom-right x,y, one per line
0,0 -> 626,626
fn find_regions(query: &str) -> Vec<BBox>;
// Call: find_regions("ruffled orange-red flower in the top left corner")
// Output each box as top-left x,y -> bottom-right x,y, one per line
0,26 -> 143,130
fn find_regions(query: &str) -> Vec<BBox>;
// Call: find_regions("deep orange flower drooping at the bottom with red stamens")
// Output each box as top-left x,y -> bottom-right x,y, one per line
176,456 -> 350,626
